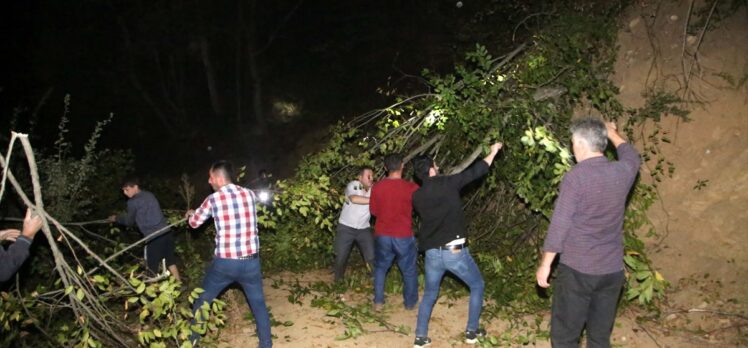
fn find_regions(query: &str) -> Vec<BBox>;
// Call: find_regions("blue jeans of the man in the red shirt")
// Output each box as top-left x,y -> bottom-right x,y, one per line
374,236 -> 418,308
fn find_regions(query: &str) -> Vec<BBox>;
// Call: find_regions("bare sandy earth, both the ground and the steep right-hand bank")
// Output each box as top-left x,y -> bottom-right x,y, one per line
213,1 -> 748,348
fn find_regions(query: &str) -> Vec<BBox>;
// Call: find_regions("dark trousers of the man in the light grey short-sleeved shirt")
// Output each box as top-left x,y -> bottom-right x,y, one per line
335,223 -> 374,281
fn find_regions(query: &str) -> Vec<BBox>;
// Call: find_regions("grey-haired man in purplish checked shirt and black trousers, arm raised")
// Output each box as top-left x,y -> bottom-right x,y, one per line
536,118 -> 640,347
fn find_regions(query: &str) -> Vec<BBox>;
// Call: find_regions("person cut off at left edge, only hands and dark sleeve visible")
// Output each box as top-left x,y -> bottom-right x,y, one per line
0,209 -> 42,282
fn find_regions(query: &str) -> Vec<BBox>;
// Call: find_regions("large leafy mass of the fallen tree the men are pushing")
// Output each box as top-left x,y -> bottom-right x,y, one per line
262,3 -> 680,316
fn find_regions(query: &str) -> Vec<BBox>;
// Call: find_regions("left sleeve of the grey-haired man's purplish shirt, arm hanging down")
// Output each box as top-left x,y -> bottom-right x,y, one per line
543,172 -> 579,253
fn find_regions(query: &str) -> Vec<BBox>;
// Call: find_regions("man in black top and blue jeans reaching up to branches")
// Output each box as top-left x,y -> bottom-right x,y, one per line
413,143 -> 502,348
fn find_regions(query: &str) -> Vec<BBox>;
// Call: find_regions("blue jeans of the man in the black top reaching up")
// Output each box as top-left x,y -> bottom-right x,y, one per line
416,248 -> 484,337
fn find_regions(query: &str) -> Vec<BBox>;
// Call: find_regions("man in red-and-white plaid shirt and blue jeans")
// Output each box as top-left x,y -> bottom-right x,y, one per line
187,161 -> 273,348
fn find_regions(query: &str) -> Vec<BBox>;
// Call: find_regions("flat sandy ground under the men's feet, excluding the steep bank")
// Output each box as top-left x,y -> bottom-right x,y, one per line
212,271 -> 746,348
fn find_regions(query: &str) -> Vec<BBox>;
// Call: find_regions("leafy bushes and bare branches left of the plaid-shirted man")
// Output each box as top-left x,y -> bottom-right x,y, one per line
0,107 -> 224,347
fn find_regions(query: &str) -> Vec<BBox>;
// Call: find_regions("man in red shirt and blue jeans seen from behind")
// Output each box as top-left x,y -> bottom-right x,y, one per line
369,154 -> 418,310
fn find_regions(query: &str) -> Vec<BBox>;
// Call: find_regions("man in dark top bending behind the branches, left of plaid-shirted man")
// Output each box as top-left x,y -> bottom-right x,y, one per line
109,177 -> 180,280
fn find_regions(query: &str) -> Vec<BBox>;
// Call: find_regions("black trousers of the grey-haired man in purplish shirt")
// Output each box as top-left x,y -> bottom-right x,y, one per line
551,264 -> 625,348
